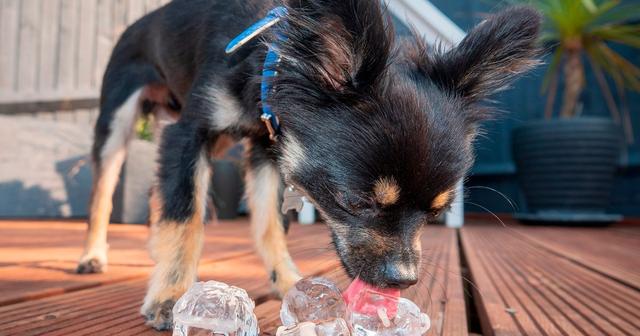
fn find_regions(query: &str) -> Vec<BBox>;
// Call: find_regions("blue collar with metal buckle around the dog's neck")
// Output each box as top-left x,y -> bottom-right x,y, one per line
225,7 -> 288,141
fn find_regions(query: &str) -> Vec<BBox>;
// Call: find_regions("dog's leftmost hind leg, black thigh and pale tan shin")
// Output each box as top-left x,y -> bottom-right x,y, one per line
76,56 -> 162,273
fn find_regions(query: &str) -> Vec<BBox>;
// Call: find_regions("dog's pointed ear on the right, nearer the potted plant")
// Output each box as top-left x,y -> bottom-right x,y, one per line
419,6 -> 541,103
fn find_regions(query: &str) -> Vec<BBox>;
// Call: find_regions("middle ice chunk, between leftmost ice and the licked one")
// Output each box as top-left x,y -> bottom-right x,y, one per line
280,277 -> 347,327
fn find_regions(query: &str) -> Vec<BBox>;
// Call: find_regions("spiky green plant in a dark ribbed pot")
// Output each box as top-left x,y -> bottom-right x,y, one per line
513,0 -> 640,224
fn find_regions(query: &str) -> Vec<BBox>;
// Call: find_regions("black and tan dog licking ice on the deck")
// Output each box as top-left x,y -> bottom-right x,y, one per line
78,0 -> 541,330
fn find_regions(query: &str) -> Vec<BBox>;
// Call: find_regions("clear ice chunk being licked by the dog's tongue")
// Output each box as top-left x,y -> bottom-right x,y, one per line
347,290 -> 431,336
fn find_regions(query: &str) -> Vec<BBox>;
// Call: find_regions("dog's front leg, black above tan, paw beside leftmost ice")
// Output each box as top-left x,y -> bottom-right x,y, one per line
141,121 -> 210,330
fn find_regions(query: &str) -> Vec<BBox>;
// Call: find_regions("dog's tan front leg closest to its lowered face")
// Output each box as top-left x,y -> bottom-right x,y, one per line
246,144 -> 300,295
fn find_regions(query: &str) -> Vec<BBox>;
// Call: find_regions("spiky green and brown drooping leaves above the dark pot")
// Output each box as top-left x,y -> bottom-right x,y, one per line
496,0 -> 640,126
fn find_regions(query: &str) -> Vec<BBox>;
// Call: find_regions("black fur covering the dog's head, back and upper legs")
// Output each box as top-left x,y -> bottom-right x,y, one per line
96,0 -> 540,310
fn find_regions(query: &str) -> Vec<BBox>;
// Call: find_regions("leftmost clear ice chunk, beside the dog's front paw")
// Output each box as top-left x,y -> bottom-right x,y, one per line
173,281 -> 259,336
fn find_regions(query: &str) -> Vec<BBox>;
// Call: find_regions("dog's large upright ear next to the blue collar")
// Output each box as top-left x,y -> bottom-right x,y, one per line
278,0 -> 394,93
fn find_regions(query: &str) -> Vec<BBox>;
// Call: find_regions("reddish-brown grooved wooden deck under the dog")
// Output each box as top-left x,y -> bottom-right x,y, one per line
0,221 -> 640,335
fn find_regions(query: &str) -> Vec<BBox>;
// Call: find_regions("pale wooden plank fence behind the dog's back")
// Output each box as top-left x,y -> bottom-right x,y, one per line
0,0 -> 169,118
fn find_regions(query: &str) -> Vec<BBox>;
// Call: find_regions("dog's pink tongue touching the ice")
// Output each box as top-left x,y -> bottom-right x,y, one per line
342,278 -> 400,318
